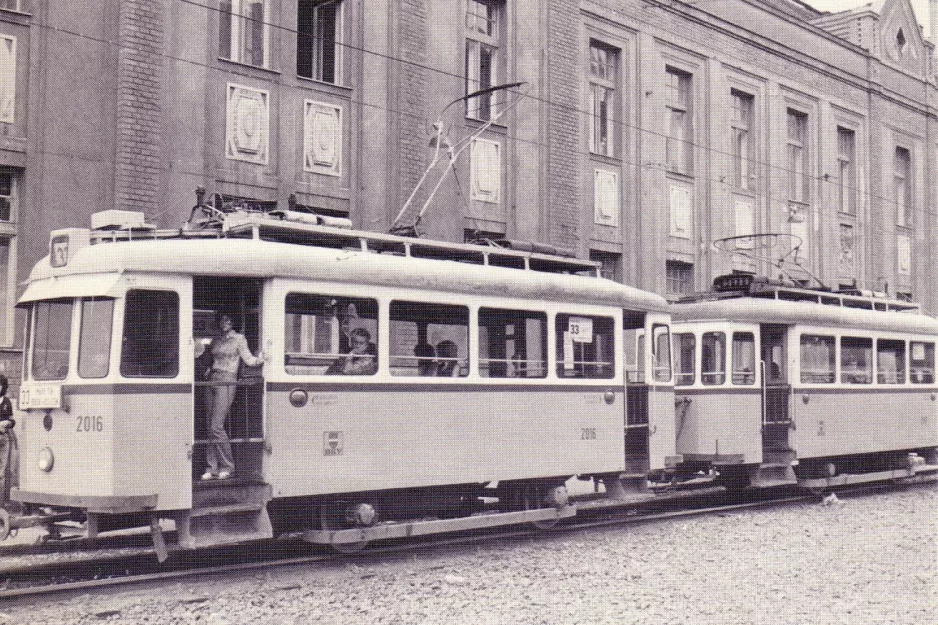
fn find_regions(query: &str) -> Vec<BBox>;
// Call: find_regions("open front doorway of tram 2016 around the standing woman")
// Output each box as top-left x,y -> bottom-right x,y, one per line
192,276 -> 264,480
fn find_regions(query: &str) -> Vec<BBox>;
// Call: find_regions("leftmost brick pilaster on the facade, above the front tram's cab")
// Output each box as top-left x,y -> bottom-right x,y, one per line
115,0 -> 164,213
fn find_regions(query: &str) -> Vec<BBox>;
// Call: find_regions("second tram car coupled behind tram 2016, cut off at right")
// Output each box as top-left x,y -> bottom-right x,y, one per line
672,275 -> 938,491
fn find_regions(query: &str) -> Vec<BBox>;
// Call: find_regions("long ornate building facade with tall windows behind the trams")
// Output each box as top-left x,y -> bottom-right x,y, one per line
0,0 -> 938,366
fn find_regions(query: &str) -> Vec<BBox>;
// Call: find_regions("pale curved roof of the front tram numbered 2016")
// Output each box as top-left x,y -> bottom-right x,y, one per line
20,238 -> 668,312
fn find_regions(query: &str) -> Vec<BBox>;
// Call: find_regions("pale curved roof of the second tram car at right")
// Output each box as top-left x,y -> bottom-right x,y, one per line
671,297 -> 938,334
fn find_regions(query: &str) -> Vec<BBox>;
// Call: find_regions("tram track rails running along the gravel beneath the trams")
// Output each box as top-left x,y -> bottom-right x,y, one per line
0,484 -> 933,602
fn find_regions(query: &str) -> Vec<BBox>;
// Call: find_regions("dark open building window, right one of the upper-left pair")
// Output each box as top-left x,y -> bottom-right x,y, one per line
296,0 -> 342,83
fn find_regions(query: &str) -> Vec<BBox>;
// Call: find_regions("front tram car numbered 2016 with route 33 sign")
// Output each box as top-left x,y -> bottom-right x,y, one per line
1,211 -> 677,558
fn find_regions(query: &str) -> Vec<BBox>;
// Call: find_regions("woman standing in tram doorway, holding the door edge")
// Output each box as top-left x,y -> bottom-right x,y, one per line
202,312 -> 264,480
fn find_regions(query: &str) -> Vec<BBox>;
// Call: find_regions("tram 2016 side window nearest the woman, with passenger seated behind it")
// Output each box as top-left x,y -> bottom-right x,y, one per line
284,293 -> 378,375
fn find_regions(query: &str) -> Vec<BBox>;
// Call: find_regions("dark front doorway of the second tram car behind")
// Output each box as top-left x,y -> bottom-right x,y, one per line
760,324 -> 791,451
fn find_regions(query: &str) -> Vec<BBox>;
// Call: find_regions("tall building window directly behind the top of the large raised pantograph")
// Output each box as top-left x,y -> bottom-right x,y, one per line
466,0 -> 504,120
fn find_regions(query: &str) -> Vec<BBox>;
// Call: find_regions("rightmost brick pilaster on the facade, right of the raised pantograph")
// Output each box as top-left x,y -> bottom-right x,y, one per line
547,0 -> 586,250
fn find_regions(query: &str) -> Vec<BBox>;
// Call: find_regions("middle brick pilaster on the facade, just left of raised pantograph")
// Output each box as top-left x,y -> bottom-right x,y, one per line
388,0 -> 431,225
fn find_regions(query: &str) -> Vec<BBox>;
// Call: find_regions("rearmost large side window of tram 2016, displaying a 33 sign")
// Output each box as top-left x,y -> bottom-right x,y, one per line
555,313 -> 616,378
